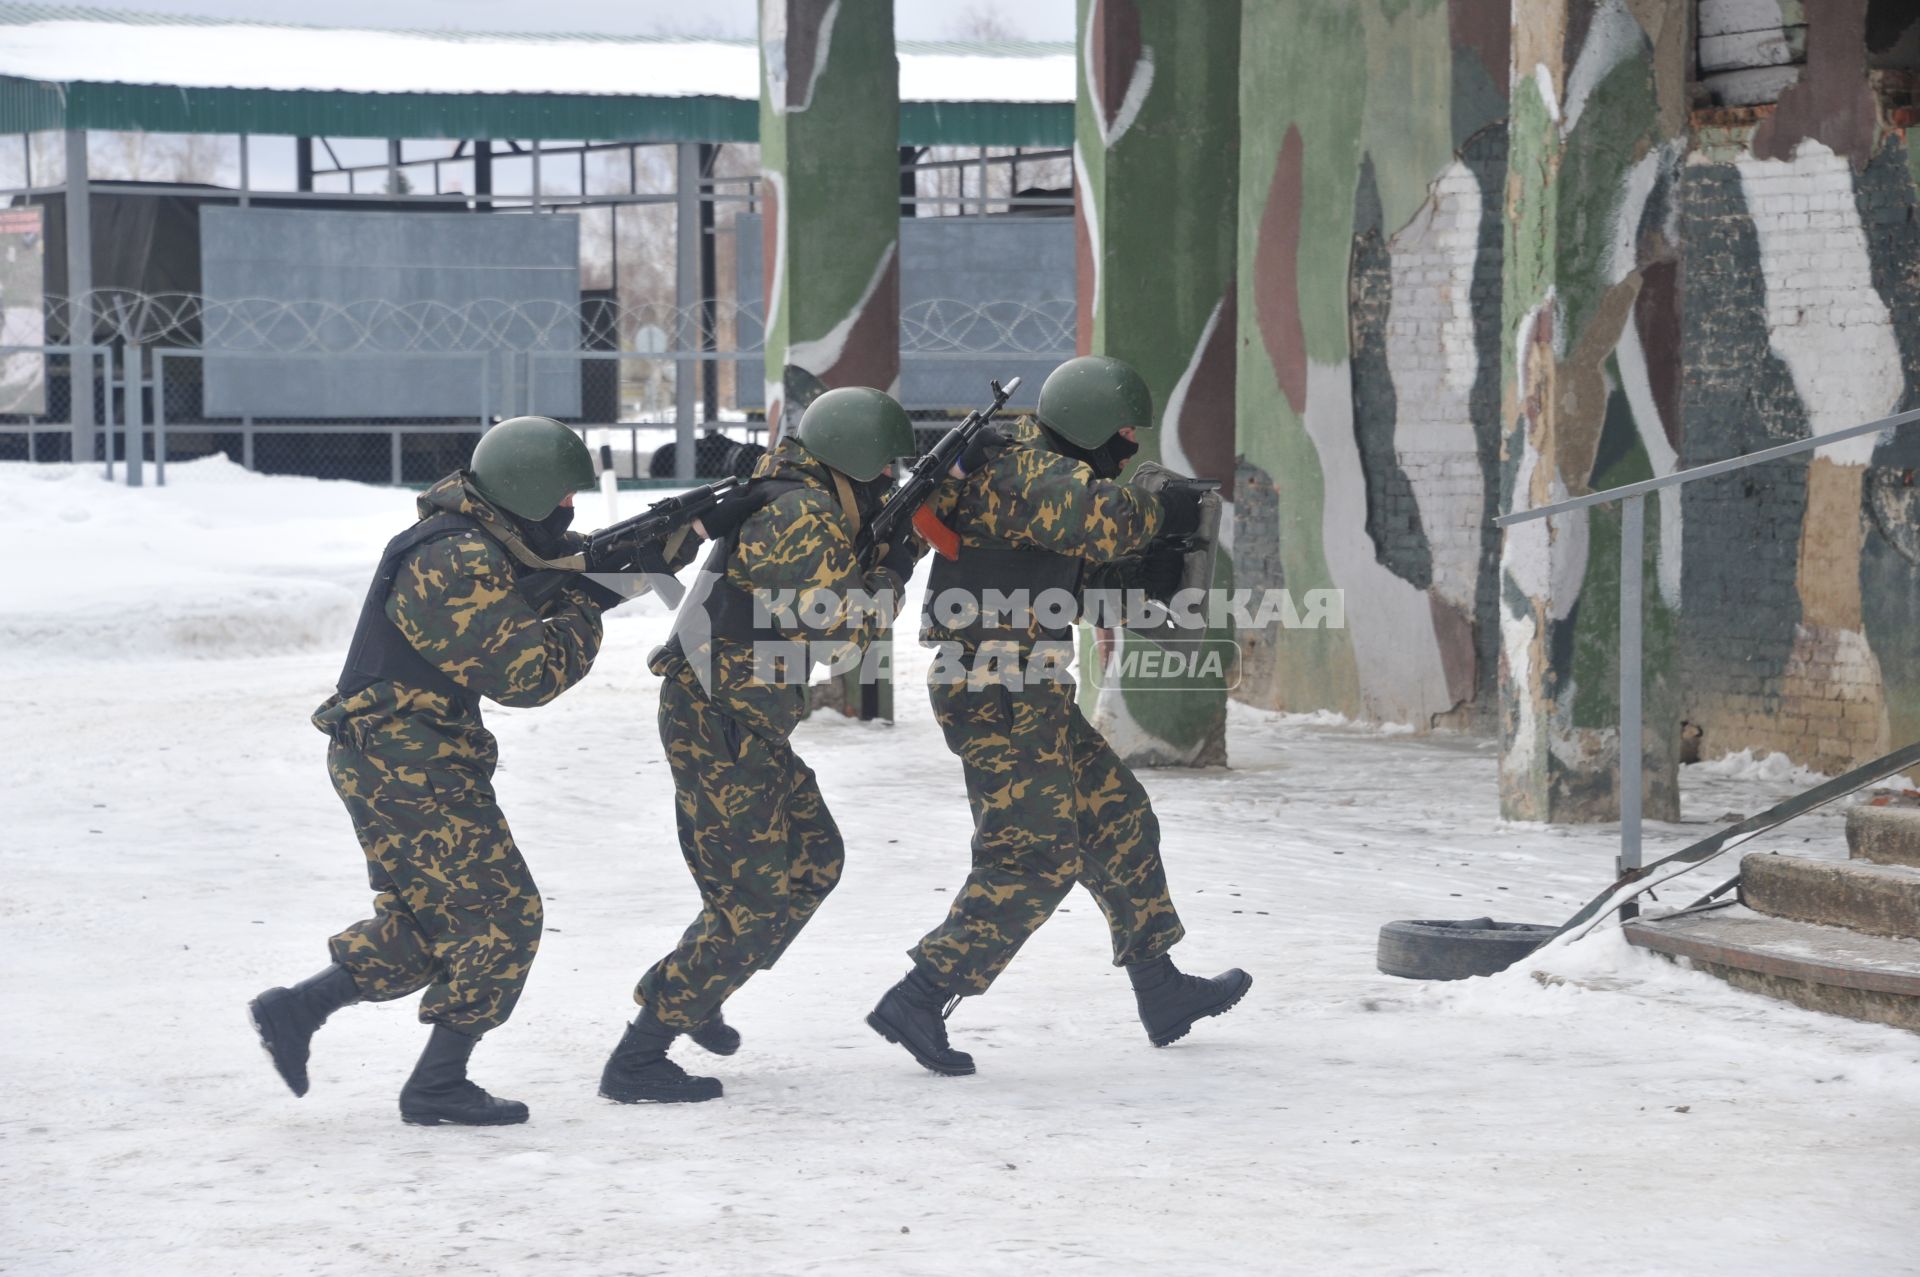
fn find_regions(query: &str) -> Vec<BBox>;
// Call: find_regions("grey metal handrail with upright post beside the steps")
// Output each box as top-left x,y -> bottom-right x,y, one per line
1494,409 -> 1920,891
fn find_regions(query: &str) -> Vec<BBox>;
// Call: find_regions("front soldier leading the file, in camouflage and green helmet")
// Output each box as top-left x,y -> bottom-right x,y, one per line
868,355 -> 1252,1075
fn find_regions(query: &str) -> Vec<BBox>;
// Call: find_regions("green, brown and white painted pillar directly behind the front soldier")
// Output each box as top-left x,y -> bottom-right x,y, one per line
1073,0 -> 1240,766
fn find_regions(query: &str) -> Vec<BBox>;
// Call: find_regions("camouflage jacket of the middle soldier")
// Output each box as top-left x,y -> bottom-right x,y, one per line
649,436 -> 902,739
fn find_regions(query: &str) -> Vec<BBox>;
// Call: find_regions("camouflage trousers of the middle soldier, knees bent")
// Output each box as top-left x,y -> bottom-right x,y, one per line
634,663 -> 845,1029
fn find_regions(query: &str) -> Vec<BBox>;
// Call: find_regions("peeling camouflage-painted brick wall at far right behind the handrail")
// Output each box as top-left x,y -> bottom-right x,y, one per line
1680,140 -> 1920,772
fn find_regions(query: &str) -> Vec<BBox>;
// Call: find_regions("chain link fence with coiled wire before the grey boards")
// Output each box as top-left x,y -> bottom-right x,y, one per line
0,290 -> 1073,484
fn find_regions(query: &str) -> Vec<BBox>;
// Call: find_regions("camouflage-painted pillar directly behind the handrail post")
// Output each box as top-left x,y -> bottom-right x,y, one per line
1500,0 -> 1693,820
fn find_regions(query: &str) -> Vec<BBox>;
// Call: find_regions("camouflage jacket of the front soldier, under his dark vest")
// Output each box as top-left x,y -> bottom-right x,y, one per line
920,417 -> 1165,653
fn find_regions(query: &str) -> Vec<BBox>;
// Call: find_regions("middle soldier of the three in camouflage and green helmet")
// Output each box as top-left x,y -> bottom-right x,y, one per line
601,388 -> 922,1102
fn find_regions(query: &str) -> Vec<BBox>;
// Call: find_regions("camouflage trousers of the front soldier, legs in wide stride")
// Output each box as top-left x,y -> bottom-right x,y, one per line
908,684 -> 1185,995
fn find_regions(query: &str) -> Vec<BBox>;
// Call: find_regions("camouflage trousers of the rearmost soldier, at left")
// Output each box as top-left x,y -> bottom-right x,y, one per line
326,741 -> 541,1037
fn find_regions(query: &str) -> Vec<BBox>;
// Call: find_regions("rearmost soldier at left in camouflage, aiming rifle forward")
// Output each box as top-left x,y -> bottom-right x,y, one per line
252,417 -> 689,1125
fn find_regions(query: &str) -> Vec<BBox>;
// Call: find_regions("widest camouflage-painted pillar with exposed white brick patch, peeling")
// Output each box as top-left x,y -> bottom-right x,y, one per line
1233,0 -> 1509,732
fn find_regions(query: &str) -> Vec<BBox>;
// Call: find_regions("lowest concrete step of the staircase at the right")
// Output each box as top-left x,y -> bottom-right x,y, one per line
1626,904 -> 1920,1033
